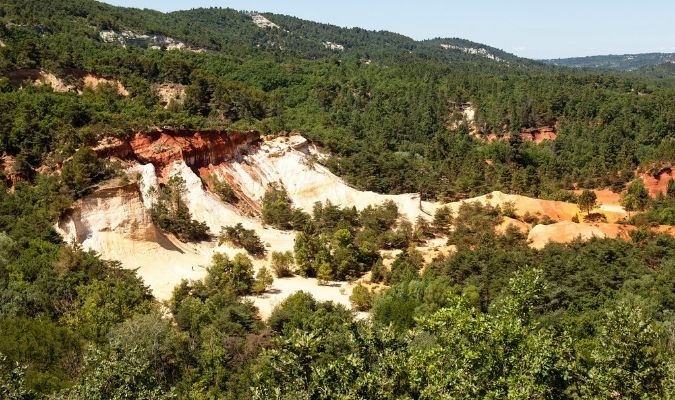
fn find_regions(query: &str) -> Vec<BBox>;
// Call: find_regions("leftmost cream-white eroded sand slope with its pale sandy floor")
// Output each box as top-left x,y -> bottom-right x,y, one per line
57,158 -> 351,318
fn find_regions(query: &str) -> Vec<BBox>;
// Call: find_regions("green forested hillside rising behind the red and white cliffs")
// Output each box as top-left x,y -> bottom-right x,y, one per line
0,1 -> 675,198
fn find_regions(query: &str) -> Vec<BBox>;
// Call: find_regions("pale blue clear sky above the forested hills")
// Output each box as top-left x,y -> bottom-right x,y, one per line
105,0 -> 675,59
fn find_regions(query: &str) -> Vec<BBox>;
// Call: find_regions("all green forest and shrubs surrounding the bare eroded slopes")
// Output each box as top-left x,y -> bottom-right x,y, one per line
0,0 -> 675,399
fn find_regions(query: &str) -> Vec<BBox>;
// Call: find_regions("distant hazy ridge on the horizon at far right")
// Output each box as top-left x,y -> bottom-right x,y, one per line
542,53 -> 675,71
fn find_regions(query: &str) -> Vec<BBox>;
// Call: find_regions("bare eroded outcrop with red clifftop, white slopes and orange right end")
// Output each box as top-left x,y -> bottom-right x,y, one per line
57,129 -> 675,318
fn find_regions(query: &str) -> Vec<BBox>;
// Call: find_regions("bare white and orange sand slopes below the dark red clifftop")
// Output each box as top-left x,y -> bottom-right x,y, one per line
57,135 -> 672,318
